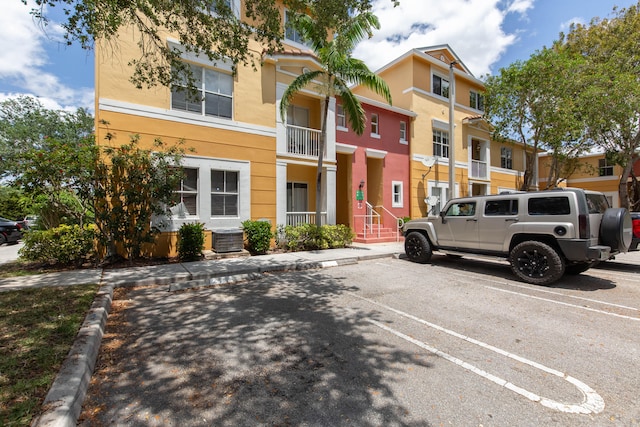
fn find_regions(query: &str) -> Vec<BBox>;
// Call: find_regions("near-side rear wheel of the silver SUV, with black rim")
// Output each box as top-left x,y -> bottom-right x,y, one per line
509,241 -> 565,285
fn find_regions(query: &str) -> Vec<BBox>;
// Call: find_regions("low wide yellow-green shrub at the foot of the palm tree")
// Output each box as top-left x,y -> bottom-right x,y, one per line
277,224 -> 355,251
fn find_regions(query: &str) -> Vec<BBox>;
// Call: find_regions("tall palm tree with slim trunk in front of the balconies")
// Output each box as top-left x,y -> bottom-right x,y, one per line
280,12 -> 391,227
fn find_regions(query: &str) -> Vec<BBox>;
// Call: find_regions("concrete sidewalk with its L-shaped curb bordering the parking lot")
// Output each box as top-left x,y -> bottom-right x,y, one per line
15,242 -> 404,427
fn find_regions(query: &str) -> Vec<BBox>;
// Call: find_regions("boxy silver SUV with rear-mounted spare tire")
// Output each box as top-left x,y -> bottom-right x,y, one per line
403,188 -> 632,285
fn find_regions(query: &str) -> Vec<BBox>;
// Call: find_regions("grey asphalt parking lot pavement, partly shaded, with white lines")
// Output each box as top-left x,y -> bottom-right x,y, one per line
80,254 -> 640,427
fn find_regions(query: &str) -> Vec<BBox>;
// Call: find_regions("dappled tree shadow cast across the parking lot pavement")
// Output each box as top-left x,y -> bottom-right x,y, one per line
80,272 -> 429,426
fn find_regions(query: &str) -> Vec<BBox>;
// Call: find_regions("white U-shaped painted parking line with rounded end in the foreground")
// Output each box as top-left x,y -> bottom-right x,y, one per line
350,293 -> 605,414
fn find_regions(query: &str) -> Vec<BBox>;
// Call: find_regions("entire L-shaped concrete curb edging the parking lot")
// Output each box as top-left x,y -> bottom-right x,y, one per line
31,252 -> 399,427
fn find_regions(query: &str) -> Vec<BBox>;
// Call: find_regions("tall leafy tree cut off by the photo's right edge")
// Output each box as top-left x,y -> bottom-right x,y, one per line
555,3 -> 640,208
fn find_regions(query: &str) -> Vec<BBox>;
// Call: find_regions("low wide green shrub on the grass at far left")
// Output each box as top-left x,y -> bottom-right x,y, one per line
18,224 -> 96,265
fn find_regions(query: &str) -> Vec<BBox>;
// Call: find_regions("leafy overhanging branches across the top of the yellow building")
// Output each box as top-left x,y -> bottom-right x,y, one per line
27,0 -> 398,88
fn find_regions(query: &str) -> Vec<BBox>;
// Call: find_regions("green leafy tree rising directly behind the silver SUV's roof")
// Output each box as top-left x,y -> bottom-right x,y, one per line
485,48 -> 589,190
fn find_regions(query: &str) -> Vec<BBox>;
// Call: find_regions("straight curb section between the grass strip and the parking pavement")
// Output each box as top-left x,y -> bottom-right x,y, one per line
31,284 -> 113,427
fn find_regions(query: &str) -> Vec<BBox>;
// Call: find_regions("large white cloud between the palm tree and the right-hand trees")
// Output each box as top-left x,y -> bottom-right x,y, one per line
353,0 -> 534,77
